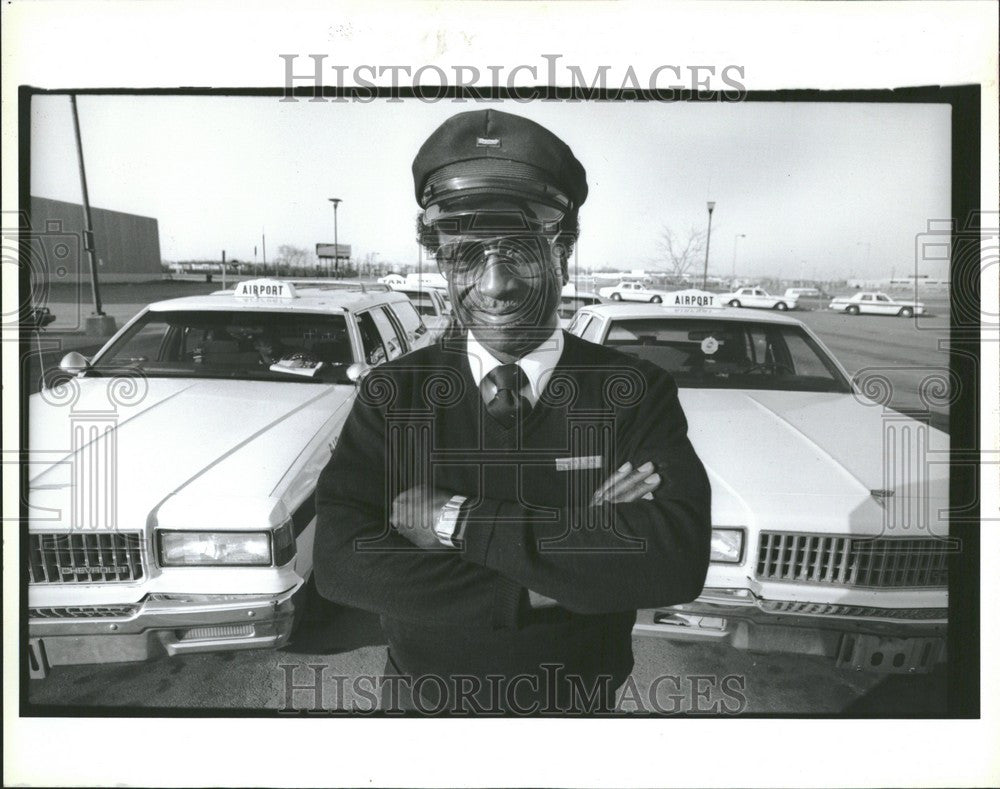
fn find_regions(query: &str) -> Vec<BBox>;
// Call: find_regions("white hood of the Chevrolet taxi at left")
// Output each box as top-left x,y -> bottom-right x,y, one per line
28,378 -> 356,528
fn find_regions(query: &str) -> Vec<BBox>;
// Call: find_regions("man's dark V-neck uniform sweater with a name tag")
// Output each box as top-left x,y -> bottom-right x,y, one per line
314,334 -> 711,704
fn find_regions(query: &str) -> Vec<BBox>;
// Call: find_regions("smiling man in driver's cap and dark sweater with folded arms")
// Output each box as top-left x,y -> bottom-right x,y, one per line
315,109 -> 711,714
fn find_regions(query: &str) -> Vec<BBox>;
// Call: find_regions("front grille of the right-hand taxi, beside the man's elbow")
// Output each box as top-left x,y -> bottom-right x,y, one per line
757,532 -> 948,589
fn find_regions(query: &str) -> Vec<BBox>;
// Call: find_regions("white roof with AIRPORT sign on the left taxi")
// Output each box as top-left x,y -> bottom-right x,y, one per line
148,279 -> 407,313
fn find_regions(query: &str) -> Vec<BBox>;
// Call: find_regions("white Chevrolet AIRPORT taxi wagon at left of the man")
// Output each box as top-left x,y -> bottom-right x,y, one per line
24,279 -> 428,676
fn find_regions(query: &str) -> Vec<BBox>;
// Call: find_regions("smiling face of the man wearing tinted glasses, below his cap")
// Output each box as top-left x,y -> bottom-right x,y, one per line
437,225 -> 567,361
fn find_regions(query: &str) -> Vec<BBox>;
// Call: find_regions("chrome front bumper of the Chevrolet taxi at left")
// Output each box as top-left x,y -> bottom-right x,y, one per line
28,589 -> 295,677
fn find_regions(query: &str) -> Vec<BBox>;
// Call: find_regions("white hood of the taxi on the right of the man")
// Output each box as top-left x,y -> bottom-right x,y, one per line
680,389 -> 949,536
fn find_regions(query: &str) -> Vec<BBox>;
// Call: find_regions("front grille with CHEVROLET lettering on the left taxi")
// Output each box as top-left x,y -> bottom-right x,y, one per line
28,532 -> 143,584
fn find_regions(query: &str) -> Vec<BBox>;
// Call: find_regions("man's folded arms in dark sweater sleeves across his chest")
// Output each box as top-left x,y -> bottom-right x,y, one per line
315,366 -> 711,622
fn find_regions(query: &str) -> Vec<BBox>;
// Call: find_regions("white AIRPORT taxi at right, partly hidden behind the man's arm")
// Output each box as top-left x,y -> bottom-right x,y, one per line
569,291 -> 956,672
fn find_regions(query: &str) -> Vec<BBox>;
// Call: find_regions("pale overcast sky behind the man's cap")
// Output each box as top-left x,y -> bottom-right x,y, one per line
31,96 -> 951,279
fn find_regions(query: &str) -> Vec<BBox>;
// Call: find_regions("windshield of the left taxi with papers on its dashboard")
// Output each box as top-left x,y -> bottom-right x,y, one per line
90,310 -> 354,383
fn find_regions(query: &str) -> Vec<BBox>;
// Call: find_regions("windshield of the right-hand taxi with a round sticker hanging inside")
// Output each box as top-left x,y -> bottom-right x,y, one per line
605,318 -> 851,393
